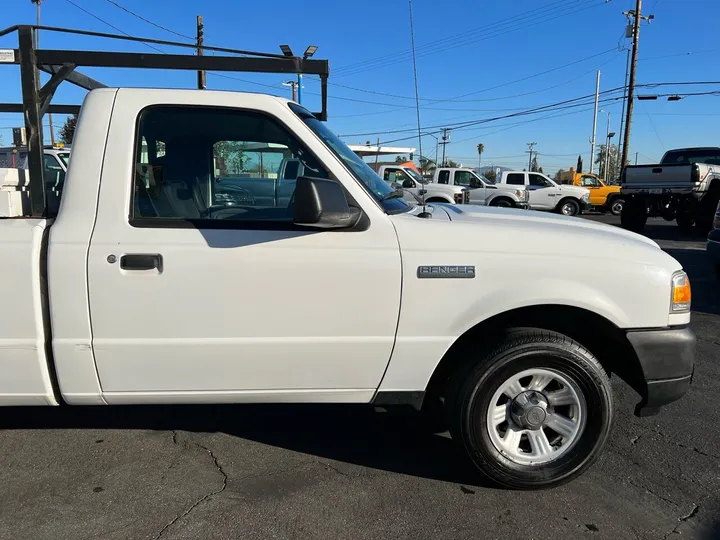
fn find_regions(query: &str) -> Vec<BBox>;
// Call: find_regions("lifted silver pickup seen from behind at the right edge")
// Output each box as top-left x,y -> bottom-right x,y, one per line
620,147 -> 720,232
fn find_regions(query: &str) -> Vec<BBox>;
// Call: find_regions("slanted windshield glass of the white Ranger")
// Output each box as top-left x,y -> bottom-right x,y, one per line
289,103 -> 411,214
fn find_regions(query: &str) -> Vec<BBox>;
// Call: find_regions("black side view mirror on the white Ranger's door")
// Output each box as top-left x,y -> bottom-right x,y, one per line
293,176 -> 362,229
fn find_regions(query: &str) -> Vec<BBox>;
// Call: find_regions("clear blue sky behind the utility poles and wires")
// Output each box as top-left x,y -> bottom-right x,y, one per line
0,0 -> 720,172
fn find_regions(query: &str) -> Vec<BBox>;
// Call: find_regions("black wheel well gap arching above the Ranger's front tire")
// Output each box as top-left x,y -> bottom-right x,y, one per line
426,305 -> 646,396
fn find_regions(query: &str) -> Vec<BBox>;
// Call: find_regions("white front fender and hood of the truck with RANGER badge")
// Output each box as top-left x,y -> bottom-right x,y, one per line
380,206 -> 681,391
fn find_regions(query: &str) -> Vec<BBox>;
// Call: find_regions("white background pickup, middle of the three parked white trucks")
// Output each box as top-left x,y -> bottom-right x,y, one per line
432,167 -> 530,210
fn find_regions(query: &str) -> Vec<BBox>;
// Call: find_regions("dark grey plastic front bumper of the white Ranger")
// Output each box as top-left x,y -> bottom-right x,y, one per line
627,326 -> 696,416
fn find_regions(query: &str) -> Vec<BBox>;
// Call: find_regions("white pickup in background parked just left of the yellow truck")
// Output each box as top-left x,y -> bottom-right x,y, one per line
495,171 -> 590,216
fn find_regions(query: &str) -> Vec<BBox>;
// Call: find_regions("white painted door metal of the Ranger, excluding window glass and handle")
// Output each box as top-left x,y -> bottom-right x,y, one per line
87,89 -> 401,401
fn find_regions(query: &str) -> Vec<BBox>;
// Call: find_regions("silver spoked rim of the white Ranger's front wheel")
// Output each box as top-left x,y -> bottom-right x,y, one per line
487,368 -> 587,465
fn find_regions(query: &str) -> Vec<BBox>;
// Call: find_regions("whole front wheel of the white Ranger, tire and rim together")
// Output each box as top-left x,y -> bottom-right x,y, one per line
448,328 -> 613,489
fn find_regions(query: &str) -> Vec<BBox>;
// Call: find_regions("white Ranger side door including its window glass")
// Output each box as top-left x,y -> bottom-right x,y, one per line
87,98 -> 401,403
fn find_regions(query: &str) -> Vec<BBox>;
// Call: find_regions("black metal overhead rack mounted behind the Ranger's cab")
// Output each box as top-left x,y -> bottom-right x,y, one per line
0,25 -> 330,217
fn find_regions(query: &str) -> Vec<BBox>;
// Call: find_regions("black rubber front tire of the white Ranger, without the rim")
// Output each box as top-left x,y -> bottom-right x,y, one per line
446,328 -> 614,489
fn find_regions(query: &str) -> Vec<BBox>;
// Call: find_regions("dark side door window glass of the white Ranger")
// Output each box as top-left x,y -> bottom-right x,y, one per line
131,107 -> 328,228
